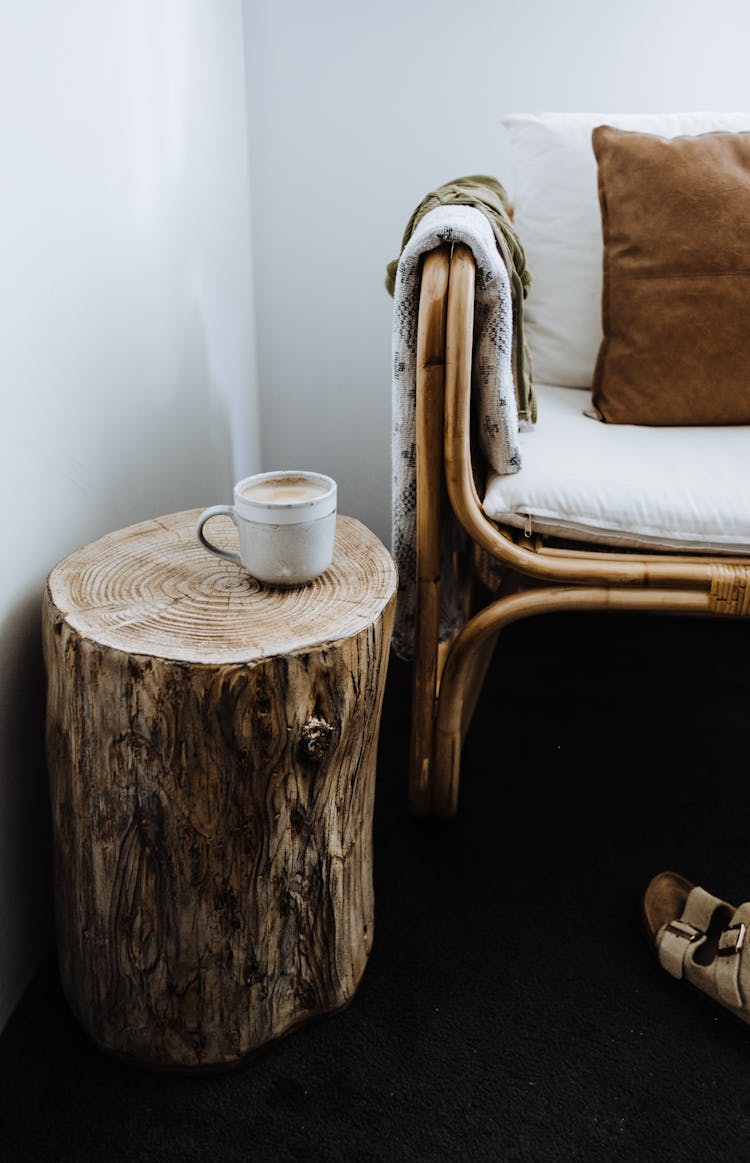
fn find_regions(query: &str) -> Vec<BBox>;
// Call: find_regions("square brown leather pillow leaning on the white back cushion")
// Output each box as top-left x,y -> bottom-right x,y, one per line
592,126 -> 750,424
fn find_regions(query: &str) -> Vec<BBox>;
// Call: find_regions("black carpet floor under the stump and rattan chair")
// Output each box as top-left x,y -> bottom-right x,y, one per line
0,614 -> 750,1163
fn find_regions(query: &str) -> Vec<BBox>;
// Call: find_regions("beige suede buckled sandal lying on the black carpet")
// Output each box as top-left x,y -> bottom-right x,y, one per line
642,872 -> 750,1023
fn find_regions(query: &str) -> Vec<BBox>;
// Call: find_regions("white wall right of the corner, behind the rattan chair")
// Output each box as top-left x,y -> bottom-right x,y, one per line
245,0 -> 750,543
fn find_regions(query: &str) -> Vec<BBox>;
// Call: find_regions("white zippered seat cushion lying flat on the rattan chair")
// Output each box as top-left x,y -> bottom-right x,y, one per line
484,384 -> 750,554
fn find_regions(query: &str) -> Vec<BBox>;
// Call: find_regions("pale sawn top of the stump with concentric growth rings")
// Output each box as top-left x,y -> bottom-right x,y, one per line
48,509 -> 395,663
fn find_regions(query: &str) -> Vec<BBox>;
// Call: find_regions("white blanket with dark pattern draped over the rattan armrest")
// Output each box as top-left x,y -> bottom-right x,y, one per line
391,206 -> 521,659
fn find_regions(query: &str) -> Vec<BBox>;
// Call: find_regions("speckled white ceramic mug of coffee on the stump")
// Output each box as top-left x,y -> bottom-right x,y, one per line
195,469 -> 337,586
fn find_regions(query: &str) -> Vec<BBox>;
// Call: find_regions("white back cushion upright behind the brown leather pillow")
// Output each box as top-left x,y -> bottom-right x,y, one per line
501,113 -> 750,387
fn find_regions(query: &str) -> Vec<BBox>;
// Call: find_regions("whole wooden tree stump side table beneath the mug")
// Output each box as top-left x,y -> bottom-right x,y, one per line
43,511 -> 395,1072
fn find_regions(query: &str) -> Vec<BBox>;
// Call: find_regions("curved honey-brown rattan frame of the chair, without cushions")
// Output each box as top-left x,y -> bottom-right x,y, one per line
409,244 -> 750,818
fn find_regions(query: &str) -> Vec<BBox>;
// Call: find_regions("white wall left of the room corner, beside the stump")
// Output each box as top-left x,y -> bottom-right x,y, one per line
0,0 -> 259,1027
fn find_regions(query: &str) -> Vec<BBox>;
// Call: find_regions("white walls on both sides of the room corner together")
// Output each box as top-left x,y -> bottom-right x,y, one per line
5,0 -> 750,1026
